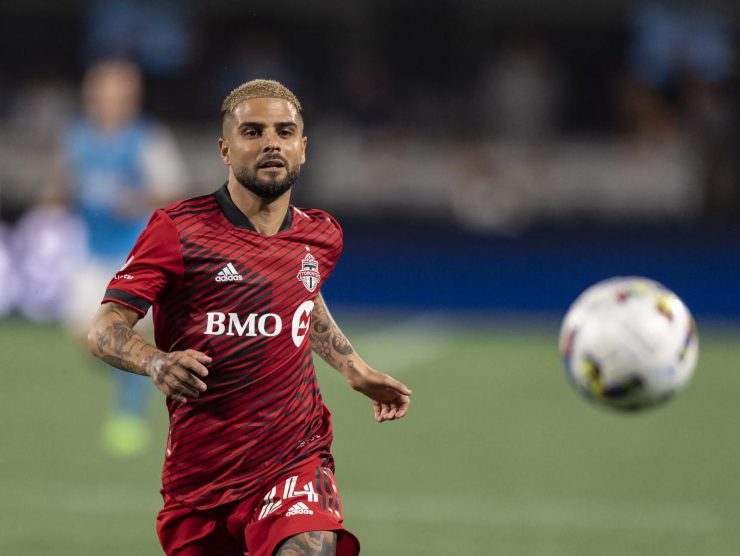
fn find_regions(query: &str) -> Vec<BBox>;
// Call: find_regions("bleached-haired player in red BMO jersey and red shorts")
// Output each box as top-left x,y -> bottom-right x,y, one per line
88,80 -> 411,556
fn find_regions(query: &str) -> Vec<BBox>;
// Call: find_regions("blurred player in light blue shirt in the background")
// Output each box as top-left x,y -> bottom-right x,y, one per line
43,59 -> 186,455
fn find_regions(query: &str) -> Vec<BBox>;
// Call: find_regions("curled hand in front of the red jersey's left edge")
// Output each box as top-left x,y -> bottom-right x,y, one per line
146,349 -> 212,403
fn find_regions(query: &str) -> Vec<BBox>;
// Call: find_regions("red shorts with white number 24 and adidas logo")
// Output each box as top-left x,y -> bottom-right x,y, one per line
157,458 -> 360,556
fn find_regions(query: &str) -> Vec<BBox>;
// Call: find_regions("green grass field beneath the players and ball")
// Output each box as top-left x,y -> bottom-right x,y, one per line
0,319 -> 740,556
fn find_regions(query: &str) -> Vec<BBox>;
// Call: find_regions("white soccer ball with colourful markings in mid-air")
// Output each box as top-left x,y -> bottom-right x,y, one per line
559,277 -> 699,411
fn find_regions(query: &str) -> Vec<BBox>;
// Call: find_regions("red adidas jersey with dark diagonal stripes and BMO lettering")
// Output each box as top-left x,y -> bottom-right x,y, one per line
103,185 -> 342,508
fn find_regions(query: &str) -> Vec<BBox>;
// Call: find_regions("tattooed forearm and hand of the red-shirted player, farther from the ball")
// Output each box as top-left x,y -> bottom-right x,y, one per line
87,302 -> 211,402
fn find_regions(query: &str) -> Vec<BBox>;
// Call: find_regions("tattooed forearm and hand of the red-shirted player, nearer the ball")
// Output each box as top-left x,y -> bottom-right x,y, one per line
311,293 -> 411,423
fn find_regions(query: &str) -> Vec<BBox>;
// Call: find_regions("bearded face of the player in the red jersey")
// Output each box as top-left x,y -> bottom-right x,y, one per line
219,98 -> 306,199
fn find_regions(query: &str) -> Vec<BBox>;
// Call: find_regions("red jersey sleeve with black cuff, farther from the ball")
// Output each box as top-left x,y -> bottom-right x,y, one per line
102,210 -> 184,315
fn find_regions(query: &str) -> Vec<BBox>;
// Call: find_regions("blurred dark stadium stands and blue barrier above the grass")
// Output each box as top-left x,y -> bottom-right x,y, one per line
0,0 -> 740,319
